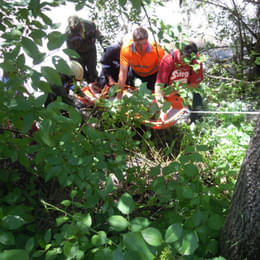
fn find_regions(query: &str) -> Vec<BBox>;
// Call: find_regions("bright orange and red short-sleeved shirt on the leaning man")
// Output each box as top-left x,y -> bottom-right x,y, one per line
120,40 -> 164,77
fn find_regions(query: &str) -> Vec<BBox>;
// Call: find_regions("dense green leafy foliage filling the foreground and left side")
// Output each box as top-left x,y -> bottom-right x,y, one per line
0,0 -> 253,260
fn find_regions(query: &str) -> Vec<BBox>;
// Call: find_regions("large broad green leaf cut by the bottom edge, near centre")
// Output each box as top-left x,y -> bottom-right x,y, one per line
123,232 -> 154,260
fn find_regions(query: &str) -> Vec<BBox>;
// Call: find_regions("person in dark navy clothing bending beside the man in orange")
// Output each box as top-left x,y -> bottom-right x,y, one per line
99,41 -> 122,86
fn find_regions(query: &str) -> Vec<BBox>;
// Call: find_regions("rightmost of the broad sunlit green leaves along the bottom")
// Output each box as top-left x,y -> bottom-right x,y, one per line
178,232 -> 199,255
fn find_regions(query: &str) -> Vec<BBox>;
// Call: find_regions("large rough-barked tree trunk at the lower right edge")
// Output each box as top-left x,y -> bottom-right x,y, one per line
220,116 -> 260,260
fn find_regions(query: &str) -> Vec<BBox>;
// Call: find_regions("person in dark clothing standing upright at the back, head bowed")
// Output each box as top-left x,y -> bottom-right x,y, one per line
66,16 -> 109,83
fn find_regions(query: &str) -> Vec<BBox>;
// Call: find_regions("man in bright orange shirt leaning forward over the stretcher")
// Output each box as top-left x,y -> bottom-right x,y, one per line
117,27 -> 164,98
